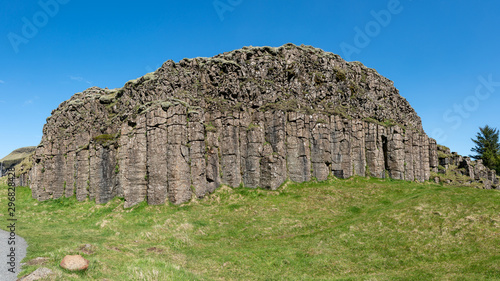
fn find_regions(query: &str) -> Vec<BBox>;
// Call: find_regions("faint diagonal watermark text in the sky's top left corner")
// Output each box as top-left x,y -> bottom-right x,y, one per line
7,0 -> 70,54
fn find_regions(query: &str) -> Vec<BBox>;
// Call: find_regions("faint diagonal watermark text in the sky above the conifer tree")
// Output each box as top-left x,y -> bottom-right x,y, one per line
432,74 -> 500,143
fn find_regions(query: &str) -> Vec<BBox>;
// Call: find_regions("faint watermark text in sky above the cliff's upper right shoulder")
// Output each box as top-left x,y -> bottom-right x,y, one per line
340,0 -> 412,61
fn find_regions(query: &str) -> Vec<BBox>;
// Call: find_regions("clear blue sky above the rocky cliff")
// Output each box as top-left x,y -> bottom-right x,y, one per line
0,0 -> 500,158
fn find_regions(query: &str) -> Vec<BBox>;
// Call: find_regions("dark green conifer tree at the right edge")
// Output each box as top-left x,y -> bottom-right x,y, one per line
470,125 -> 500,174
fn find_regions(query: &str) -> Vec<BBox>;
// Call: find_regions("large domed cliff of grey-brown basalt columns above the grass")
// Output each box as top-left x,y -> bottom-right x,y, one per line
31,44 -> 439,207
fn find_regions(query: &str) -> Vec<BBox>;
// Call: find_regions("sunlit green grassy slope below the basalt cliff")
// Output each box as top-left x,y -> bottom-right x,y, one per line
0,178 -> 500,280
